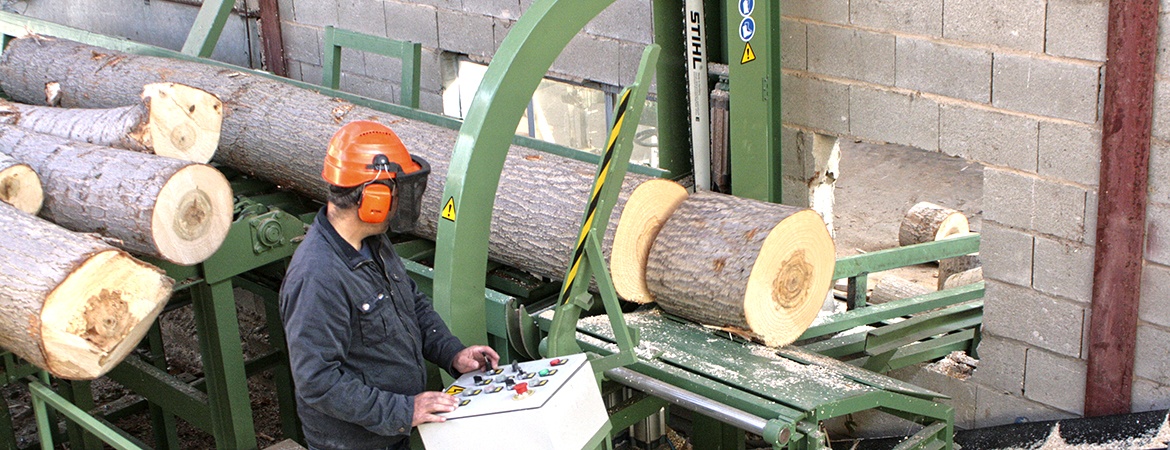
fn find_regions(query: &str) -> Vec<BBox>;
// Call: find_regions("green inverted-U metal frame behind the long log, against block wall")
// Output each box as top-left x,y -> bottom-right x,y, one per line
321,27 -> 422,109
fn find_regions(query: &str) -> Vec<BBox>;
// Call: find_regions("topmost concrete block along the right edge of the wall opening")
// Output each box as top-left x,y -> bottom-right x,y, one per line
983,167 -> 1035,229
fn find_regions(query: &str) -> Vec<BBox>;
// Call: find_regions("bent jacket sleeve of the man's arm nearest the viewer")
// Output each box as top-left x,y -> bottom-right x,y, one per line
281,278 -> 414,436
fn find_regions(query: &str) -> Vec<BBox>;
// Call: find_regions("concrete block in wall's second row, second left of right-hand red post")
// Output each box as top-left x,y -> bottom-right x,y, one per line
895,36 -> 991,103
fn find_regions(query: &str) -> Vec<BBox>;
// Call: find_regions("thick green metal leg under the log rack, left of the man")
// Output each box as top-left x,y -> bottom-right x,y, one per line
192,281 -> 256,449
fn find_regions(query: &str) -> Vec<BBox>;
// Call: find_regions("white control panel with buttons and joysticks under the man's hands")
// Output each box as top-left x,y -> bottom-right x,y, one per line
419,354 -> 608,450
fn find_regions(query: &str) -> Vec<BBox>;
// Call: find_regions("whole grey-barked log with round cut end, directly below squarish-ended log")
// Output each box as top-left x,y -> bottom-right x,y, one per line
0,125 -> 234,265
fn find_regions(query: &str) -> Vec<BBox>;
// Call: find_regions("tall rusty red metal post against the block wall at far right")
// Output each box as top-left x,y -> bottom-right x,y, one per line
1085,0 -> 1158,416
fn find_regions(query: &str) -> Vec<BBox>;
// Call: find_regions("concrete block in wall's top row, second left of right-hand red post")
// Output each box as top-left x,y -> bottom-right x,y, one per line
943,0 -> 1045,53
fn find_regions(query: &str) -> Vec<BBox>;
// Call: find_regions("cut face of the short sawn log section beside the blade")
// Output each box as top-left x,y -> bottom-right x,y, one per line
744,209 -> 835,346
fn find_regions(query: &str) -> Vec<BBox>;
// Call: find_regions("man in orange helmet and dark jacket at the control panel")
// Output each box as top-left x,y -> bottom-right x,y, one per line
281,122 -> 500,450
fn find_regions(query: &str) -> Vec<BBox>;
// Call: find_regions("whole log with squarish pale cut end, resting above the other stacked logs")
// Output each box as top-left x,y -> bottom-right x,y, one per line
0,83 -> 223,162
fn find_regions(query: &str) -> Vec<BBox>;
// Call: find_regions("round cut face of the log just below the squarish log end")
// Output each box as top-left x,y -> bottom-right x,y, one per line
151,164 -> 233,265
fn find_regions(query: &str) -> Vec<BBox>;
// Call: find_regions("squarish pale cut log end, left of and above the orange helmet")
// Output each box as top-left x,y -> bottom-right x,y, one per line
140,83 -> 223,162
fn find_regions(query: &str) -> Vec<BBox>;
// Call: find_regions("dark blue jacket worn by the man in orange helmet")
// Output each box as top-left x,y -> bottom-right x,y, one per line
281,208 -> 463,449
